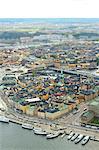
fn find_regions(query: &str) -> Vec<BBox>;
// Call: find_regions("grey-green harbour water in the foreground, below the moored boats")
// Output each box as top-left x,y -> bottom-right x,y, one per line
0,123 -> 99,150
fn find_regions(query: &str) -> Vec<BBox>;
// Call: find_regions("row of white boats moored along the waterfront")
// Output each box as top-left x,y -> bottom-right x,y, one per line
0,116 -> 99,145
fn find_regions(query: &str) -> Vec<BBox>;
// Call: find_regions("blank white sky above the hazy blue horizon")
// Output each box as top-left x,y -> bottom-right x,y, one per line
0,0 -> 99,18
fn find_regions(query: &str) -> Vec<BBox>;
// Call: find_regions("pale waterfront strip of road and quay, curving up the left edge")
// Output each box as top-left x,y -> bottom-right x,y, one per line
0,89 -> 99,142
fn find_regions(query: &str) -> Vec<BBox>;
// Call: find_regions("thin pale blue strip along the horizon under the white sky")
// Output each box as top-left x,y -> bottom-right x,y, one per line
0,18 -> 99,23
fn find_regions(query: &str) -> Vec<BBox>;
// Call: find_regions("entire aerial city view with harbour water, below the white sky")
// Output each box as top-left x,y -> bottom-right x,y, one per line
0,18 -> 99,150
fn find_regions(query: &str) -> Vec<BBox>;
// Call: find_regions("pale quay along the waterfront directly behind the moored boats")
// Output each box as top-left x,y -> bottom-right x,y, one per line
1,95 -> 99,142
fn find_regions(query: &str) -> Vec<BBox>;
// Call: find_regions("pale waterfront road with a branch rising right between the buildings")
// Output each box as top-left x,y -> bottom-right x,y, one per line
1,93 -> 99,139
